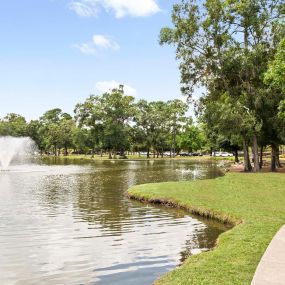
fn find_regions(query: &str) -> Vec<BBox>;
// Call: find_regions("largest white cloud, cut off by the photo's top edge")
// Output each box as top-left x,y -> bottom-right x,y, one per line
67,0 -> 160,18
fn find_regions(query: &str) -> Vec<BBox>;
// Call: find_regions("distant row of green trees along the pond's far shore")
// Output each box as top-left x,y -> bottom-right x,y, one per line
0,86 -> 206,158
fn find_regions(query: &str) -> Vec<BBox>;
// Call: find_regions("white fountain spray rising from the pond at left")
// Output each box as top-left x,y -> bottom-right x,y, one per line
0,136 -> 36,172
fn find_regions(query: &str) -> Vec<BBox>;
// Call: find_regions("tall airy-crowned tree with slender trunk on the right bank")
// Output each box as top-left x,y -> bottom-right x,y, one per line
160,0 -> 284,171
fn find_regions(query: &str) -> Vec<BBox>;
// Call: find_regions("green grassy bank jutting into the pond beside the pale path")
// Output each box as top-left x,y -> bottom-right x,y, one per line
128,173 -> 285,285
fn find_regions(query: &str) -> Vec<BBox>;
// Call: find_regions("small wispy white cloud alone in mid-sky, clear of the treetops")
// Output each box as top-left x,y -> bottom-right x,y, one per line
73,35 -> 120,55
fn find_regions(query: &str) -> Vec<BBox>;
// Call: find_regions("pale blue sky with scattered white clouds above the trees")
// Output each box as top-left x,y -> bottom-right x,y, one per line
0,0 -> 193,120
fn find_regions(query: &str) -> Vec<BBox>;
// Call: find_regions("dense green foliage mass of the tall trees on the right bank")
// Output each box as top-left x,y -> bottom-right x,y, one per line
160,0 -> 285,170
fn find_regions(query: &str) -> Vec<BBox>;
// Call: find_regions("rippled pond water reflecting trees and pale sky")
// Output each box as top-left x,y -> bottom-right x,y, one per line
0,160 -> 226,285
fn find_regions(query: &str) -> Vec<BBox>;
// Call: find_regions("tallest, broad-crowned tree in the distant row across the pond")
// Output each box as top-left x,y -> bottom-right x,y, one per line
75,86 -> 135,158
